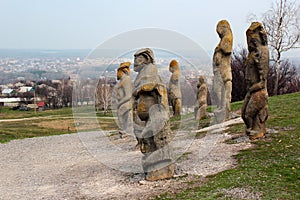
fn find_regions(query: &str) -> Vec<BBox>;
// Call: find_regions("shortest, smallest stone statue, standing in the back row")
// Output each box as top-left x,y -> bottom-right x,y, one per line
196,76 -> 207,120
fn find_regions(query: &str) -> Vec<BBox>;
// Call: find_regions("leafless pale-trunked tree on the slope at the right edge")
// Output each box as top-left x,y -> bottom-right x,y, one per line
262,0 -> 300,95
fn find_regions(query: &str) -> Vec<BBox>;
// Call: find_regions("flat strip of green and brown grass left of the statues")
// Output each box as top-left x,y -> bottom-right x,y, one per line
0,106 -> 117,143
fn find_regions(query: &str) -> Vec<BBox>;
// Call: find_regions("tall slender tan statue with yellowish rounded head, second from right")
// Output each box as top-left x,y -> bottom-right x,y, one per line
213,20 -> 233,123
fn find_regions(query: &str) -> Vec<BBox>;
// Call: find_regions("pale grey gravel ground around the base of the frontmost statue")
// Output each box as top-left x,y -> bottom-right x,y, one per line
0,117 -> 251,200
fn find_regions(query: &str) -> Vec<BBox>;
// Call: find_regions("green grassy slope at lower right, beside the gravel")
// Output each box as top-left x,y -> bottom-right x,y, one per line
156,93 -> 300,200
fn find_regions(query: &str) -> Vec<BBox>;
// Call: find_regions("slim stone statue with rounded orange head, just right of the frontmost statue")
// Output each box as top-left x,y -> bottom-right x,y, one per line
169,60 -> 181,116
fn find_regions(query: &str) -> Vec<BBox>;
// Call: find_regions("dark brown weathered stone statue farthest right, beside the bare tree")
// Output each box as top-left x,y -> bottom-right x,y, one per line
242,22 -> 269,139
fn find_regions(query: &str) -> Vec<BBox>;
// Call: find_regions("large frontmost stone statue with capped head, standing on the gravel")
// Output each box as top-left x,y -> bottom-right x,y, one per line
133,48 -> 174,181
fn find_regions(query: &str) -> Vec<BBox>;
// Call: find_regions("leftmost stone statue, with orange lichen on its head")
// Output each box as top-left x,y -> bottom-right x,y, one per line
116,62 -> 133,137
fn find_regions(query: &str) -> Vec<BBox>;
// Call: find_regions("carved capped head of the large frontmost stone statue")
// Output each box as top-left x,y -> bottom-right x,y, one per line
133,48 -> 154,72
